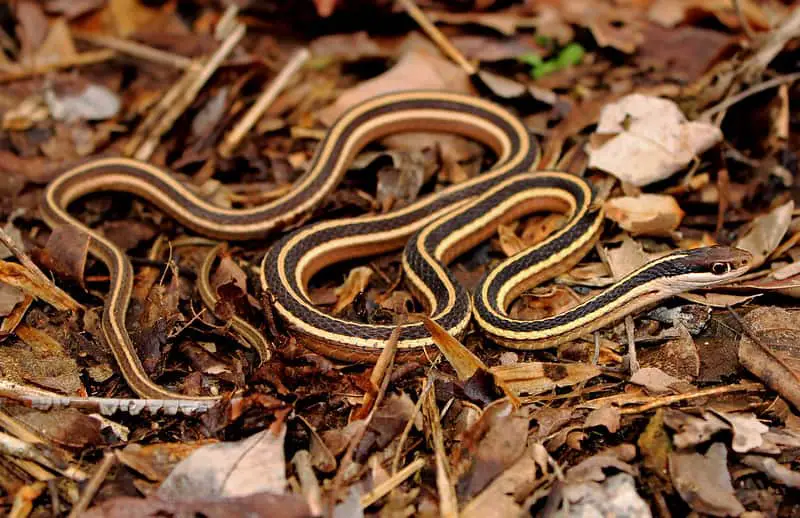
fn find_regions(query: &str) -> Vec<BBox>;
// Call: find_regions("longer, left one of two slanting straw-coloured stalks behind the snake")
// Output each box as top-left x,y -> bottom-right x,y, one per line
133,25 -> 246,160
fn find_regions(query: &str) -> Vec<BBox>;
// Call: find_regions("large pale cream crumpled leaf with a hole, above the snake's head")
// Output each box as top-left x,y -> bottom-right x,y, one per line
589,94 -> 722,187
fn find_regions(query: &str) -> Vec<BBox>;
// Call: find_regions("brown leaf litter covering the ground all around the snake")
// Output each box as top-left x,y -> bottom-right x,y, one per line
0,0 -> 800,518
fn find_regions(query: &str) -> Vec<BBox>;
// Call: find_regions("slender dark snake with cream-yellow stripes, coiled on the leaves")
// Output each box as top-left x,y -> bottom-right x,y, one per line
41,91 -> 751,400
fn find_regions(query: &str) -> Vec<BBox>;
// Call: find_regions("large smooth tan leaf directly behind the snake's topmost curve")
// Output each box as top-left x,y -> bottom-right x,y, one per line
319,49 -> 472,125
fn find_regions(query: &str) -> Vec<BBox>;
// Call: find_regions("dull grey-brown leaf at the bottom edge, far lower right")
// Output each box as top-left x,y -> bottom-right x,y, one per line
669,442 -> 745,516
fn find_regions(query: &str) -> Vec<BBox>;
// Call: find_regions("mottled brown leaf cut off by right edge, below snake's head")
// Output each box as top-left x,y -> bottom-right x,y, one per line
739,307 -> 800,409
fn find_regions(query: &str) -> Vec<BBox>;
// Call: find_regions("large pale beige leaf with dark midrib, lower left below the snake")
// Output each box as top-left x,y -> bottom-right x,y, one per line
156,421 -> 286,500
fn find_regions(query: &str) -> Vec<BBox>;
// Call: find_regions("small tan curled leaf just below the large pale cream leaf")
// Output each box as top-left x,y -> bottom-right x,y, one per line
605,194 -> 684,236
